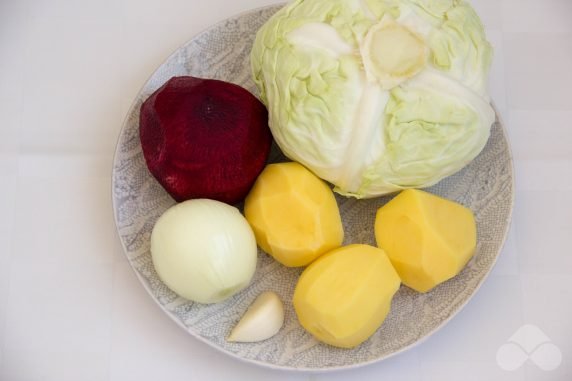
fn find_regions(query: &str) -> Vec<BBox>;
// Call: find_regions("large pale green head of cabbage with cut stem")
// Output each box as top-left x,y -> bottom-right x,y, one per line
251,0 -> 495,198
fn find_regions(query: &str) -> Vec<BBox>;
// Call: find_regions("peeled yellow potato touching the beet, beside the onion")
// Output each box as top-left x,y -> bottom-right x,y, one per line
244,162 -> 344,267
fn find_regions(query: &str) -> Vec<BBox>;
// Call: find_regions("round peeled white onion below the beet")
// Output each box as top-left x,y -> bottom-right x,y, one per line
151,199 -> 257,303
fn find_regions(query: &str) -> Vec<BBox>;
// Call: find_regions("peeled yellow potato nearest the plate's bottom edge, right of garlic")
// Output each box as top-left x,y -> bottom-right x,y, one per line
293,245 -> 400,348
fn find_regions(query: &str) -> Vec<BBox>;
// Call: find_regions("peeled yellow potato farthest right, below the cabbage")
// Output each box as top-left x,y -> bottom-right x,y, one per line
375,189 -> 477,292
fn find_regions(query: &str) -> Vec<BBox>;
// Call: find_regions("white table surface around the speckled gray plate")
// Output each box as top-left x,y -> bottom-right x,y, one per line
0,0 -> 572,381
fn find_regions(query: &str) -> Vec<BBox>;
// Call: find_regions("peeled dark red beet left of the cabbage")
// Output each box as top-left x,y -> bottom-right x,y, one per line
139,77 -> 272,204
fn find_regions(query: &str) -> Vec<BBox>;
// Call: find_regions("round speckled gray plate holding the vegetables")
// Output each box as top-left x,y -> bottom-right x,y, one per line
112,2 -> 514,371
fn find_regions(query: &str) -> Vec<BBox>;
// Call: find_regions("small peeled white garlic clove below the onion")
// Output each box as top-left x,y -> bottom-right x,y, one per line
227,291 -> 284,343
